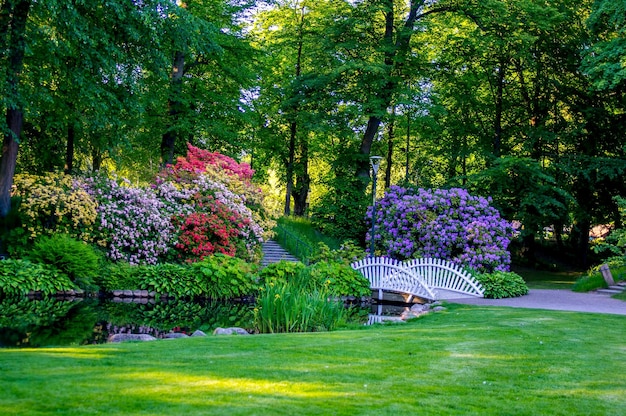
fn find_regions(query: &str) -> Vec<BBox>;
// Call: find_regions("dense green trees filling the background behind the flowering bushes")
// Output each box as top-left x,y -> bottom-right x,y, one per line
0,0 -> 626,263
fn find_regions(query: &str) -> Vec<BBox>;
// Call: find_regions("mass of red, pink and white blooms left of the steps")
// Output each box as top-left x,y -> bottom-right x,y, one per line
154,145 -> 273,261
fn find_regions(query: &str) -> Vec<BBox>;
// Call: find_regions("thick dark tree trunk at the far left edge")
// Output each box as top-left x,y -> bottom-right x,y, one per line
0,0 -> 31,217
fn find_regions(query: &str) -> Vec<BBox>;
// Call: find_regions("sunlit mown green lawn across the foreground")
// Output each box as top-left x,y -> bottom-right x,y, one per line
0,305 -> 626,416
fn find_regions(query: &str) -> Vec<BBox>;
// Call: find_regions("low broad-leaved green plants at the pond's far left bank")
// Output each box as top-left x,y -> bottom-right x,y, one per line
0,260 -> 76,296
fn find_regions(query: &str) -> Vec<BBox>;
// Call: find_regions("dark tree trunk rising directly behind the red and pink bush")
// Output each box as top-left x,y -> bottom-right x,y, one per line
161,51 -> 185,166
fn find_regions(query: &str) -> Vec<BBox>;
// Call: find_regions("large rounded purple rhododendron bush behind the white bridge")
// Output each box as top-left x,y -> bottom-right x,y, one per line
367,186 -> 512,273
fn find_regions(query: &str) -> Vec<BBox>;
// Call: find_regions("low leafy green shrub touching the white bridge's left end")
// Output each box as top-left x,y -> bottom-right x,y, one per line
304,261 -> 371,297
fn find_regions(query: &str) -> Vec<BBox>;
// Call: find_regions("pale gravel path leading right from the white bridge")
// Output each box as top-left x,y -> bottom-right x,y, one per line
446,289 -> 626,315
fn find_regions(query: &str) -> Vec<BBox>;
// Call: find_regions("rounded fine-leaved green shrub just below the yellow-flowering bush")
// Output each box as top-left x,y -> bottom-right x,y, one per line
29,234 -> 99,288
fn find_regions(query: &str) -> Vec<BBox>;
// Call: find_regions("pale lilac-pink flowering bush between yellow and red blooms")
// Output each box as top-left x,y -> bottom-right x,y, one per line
87,178 -> 174,264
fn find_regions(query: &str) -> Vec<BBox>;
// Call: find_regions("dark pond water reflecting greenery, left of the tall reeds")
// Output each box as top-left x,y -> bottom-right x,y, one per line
0,297 -> 254,348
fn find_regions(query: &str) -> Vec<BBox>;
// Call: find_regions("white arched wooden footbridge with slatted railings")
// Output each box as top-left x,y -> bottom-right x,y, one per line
351,257 -> 485,302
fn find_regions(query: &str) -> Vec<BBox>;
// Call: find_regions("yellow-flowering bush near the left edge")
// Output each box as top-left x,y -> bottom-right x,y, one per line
13,173 -> 97,240
